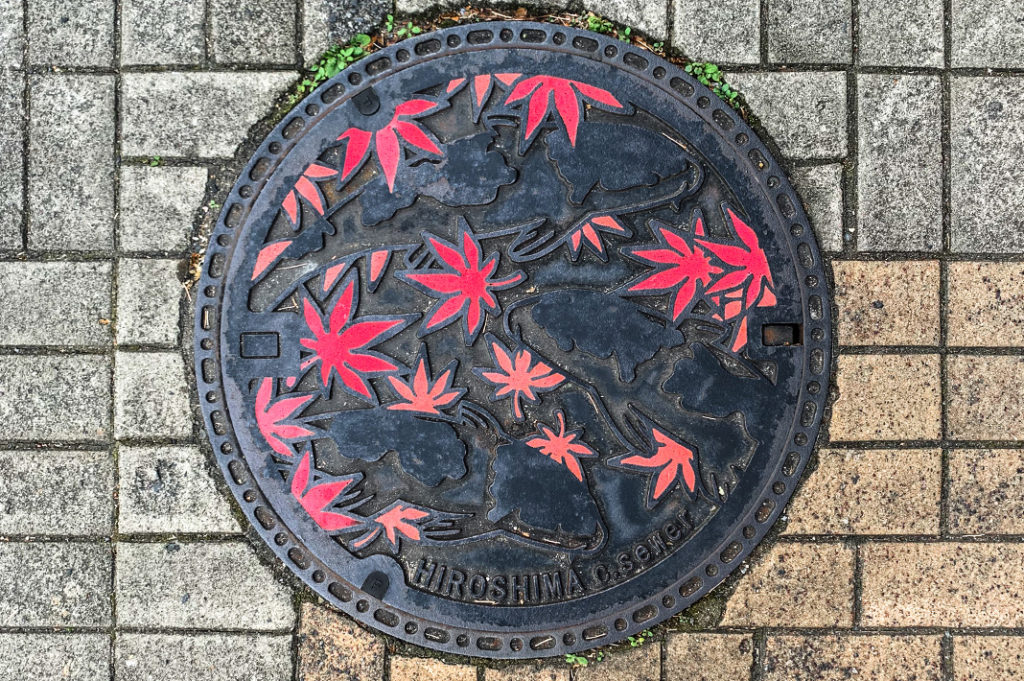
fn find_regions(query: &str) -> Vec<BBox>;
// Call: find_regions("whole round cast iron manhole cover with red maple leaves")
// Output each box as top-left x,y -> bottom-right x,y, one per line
196,24 -> 830,657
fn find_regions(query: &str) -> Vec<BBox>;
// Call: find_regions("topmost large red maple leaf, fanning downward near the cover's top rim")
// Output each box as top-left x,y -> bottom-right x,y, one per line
505,76 -> 623,146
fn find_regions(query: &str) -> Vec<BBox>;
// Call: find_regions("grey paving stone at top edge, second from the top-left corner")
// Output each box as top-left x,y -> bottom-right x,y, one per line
27,0 -> 114,65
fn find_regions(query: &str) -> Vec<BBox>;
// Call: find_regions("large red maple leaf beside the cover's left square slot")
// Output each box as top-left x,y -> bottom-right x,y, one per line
299,271 -> 411,402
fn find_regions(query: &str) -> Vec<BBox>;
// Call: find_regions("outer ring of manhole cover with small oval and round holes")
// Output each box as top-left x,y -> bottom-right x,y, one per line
195,22 -> 833,658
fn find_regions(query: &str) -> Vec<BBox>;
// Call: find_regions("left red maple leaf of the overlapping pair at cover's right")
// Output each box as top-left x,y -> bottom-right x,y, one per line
626,216 -> 722,322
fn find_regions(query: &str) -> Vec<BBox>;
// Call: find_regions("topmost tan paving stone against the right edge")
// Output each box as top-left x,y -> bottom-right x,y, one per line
946,262 -> 1024,347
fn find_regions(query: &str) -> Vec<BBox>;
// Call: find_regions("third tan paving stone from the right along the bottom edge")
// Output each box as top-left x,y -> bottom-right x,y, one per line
665,634 -> 754,681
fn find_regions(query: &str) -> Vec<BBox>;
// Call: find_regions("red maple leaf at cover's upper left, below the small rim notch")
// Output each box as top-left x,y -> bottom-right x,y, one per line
338,99 -> 442,191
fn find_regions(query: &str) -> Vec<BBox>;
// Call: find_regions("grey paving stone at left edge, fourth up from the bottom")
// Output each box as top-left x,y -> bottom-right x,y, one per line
0,355 -> 111,441
